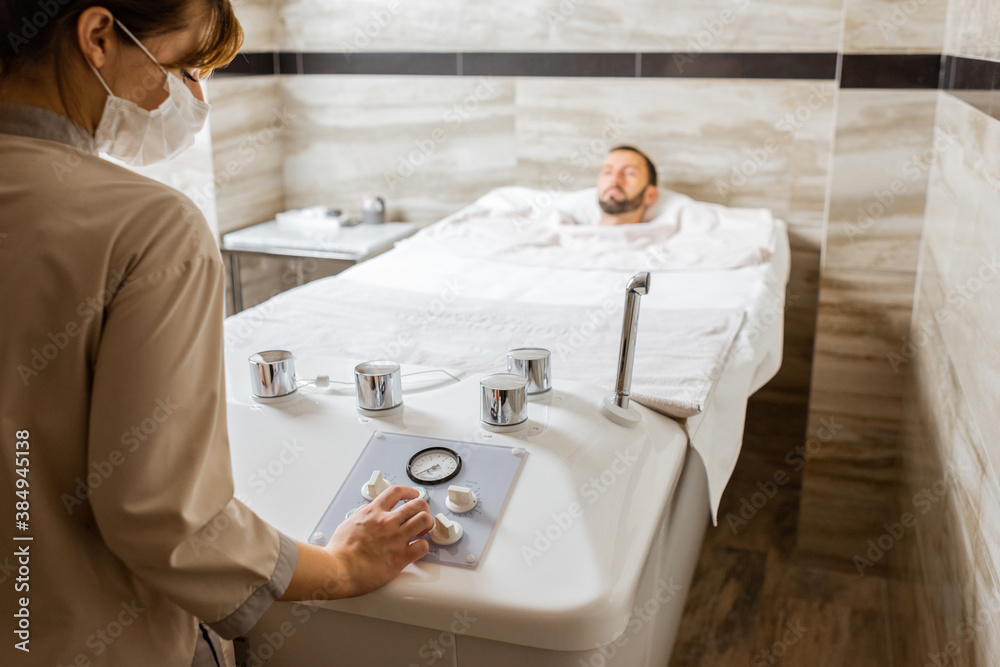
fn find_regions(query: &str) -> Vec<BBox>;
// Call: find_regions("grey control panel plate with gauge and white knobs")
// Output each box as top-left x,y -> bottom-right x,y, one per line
309,432 -> 527,568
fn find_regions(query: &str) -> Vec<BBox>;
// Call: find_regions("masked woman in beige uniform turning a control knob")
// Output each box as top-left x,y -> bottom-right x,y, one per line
0,0 -> 433,667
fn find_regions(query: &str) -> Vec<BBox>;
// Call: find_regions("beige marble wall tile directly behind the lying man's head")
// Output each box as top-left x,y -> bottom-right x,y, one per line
517,79 -> 836,220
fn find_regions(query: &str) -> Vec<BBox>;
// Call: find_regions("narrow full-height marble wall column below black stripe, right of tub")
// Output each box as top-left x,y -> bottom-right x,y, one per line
799,90 -> 938,572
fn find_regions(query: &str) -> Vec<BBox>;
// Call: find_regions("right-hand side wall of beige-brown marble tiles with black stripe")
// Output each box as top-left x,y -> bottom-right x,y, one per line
891,0 -> 1000,666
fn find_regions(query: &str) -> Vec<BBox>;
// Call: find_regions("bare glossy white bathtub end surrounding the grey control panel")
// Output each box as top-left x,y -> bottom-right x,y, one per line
229,359 -> 709,667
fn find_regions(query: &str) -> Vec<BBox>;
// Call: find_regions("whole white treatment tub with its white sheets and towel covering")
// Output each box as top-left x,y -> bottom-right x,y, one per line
226,188 -> 789,667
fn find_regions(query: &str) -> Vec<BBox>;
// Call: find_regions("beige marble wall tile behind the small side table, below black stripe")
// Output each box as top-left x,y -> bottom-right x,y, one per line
281,76 -> 516,223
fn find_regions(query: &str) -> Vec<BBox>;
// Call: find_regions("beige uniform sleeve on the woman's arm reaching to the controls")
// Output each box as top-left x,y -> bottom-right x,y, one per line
89,253 -> 298,638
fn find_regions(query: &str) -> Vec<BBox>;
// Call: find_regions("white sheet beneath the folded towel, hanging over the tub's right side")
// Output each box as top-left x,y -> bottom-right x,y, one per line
227,221 -> 790,522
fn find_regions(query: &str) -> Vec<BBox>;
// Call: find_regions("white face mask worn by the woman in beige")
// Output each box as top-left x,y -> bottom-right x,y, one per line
88,19 -> 211,167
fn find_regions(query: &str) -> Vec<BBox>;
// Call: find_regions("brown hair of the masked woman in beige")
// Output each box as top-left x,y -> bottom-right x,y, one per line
0,0 -> 243,124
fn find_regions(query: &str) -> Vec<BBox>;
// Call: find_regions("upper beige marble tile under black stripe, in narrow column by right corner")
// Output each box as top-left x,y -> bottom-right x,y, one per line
823,90 -> 947,272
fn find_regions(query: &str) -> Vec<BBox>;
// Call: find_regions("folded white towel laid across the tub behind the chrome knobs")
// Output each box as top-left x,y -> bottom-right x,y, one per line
226,278 -> 743,418
